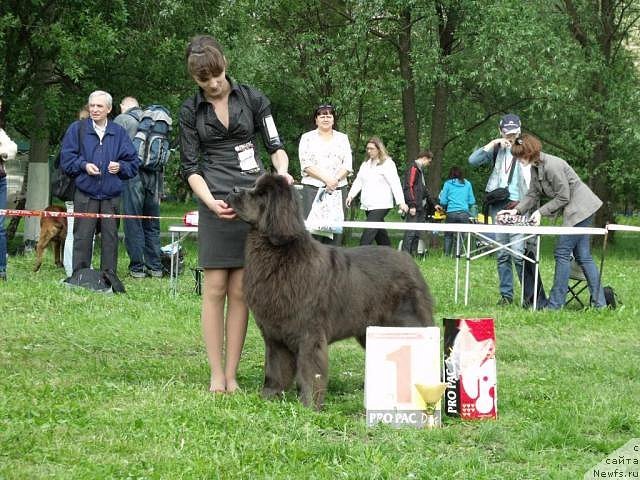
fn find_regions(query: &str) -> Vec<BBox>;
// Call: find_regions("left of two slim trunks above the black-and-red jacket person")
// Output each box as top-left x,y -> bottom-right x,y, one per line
398,9 -> 420,162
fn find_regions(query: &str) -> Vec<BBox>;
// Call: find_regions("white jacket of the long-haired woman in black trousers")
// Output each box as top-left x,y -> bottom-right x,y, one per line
348,158 -> 405,210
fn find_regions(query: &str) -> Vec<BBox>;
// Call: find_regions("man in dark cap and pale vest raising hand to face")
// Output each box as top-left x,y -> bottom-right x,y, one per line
469,113 -> 530,305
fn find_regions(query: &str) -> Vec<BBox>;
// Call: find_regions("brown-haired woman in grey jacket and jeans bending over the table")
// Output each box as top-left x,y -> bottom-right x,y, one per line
498,133 -> 606,310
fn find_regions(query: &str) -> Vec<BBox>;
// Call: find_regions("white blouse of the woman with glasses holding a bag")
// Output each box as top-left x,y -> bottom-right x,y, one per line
298,129 -> 353,187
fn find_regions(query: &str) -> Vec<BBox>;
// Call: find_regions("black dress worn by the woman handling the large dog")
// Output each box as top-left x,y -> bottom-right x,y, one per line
180,77 -> 282,268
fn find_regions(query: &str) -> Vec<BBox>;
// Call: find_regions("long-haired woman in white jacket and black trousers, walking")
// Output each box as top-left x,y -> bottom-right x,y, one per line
347,137 -> 409,246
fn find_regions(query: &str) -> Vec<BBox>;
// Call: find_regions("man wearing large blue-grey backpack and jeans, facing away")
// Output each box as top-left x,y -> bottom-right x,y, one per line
114,97 -> 171,278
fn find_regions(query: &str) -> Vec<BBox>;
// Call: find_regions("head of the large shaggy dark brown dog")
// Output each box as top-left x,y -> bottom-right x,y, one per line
226,174 -> 306,245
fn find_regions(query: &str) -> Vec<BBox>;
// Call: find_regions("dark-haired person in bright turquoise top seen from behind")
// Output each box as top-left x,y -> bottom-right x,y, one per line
436,166 -> 476,256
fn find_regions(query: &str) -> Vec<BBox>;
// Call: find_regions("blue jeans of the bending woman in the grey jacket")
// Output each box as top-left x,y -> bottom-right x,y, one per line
548,217 -> 606,310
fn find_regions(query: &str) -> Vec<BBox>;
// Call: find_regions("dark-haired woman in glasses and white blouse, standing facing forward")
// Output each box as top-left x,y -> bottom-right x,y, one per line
298,105 -> 353,245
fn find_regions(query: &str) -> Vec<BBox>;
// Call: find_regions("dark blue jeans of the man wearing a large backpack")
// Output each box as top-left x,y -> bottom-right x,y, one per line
122,170 -> 162,272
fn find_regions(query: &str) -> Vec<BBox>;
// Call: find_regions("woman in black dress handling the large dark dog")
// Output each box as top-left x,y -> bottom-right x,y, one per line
180,36 -> 293,392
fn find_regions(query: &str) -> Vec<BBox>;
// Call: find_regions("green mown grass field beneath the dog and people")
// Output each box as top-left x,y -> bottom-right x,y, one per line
0,214 -> 640,479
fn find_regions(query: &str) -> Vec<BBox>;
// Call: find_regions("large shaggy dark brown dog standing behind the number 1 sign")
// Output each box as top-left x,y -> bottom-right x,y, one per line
227,175 -> 433,409
